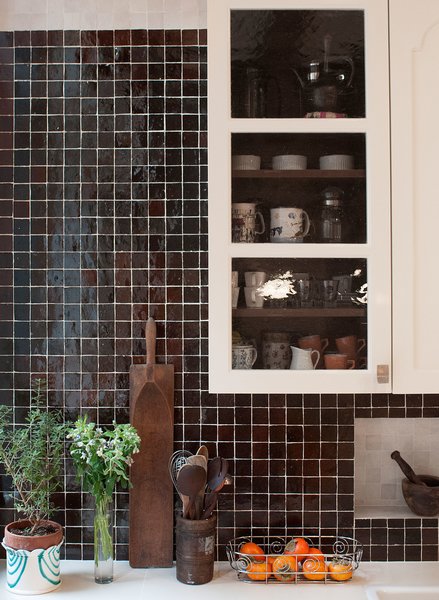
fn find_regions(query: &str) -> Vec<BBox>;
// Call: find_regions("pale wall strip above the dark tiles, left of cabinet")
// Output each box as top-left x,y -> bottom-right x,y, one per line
0,0 -> 208,31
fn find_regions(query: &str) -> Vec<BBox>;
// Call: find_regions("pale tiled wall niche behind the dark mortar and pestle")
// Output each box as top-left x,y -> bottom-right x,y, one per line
355,418 -> 439,518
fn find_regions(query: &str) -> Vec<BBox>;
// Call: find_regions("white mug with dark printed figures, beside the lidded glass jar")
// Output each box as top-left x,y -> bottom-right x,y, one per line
270,206 -> 311,244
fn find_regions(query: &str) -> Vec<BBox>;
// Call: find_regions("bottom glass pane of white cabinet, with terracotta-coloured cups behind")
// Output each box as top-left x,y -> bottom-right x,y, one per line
232,258 -> 368,369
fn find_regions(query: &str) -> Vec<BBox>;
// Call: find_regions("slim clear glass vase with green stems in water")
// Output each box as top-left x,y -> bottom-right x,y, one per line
93,498 -> 114,583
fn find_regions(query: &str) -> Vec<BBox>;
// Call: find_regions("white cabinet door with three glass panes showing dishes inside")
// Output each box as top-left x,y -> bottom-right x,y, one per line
208,0 -> 391,393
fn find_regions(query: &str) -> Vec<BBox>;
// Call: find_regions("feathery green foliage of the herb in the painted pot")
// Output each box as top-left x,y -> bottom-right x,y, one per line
0,378 -> 66,535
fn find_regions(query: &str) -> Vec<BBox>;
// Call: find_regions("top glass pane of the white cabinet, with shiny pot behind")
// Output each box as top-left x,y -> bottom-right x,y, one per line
231,10 -> 365,118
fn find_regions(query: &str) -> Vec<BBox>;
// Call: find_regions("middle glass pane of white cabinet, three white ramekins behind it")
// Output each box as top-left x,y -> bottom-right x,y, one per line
231,133 -> 367,244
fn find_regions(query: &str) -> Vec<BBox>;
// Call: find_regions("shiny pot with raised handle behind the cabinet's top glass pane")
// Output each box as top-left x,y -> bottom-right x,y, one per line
293,34 -> 355,113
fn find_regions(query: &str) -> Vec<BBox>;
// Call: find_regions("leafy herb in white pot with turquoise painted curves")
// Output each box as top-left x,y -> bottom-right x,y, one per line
0,378 -> 66,594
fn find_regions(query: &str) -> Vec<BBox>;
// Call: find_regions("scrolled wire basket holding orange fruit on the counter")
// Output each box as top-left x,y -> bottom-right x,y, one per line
226,536 -> 363,584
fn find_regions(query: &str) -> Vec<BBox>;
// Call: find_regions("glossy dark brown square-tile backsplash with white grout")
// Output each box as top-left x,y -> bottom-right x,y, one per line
0,30 -> 439,560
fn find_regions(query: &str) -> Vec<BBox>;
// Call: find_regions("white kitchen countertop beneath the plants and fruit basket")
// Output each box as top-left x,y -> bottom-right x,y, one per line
0,560 -> 439,600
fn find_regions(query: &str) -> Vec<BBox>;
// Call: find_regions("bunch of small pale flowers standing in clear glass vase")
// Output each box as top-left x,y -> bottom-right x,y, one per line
67,416 -> 140,583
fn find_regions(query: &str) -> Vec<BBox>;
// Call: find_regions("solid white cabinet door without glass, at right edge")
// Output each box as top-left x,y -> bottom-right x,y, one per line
390,0 -> 439,393
